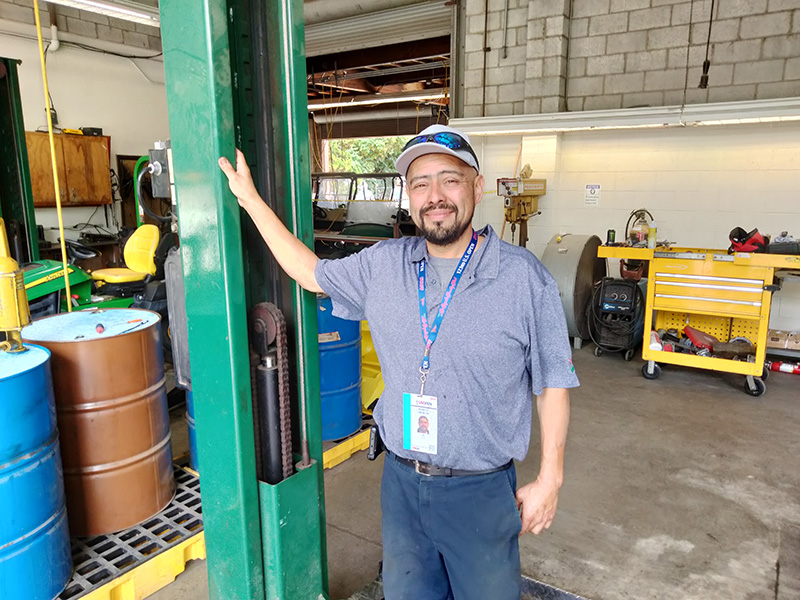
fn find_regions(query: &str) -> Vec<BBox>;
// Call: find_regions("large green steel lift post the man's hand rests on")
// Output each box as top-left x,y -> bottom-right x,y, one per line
160,0 -> 327,600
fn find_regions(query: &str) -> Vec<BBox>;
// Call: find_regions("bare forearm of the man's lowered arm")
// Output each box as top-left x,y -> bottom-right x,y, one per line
536,388 -> 569,487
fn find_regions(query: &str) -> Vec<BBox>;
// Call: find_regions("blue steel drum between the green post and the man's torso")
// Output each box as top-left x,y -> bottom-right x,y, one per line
317,296 -> 361,441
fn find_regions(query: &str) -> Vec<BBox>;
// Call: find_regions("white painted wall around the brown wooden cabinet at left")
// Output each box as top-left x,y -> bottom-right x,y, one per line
0,22 -> 169,240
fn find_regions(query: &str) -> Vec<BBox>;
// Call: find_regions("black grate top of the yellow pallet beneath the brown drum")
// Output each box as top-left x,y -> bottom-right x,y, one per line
59,467 -> 203,600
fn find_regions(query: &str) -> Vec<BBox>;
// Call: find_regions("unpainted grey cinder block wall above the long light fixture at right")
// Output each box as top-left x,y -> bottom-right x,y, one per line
463,0 -> 800,117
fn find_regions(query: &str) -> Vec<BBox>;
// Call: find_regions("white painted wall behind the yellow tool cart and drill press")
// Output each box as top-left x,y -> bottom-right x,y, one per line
472,122 -> 800,331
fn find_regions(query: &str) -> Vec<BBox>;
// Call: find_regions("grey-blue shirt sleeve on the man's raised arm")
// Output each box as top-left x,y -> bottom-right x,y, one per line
314,246 -> 375,321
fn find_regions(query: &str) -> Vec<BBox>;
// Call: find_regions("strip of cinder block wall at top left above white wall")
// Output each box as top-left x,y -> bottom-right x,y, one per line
0,0 -> 161,52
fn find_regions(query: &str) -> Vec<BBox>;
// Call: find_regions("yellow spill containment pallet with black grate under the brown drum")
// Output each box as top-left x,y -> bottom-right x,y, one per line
59,468 -> 206,600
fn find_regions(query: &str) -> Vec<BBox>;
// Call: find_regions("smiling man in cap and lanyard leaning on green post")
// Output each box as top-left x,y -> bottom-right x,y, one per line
220,125 -> 578,600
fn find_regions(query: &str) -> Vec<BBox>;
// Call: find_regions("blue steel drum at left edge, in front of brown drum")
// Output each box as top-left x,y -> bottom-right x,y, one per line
0,345 -> 72,600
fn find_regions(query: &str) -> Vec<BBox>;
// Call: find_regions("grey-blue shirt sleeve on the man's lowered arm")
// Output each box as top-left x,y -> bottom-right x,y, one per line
530,277 -> 580,396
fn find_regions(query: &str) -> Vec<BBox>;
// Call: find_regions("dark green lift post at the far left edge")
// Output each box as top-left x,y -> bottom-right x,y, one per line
0,58 -> 39,263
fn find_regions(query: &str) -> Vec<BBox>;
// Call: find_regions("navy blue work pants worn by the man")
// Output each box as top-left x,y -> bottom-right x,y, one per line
381,452 -> 522,600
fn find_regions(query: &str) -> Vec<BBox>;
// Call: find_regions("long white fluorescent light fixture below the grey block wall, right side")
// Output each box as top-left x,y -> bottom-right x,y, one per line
449,98 -> 800,135
